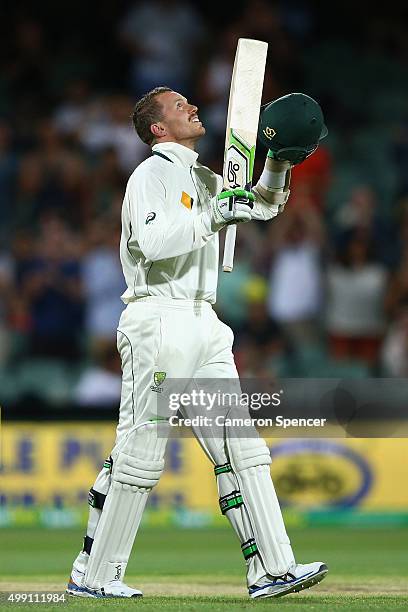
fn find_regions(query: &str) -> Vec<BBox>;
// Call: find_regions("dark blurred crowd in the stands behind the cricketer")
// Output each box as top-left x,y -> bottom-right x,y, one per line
0,0 -> 408,406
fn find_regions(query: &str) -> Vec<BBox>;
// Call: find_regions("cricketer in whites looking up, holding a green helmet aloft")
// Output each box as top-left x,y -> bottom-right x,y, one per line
67,87 -> 328,598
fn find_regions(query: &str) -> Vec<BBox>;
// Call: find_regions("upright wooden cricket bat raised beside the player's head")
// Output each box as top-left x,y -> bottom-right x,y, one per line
222,38 -> 268,272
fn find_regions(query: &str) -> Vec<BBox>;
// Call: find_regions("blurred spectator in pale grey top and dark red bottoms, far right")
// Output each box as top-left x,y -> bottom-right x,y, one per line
326,231 -> 388,366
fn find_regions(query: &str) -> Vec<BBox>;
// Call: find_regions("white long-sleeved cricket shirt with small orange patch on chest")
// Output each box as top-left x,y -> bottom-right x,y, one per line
120,142 -> 276,304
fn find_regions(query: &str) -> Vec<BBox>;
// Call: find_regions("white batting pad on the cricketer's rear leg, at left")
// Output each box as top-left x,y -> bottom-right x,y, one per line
84,423 -> 169,589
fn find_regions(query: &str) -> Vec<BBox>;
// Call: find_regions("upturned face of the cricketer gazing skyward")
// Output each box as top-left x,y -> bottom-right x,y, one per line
154,91 -> 205,146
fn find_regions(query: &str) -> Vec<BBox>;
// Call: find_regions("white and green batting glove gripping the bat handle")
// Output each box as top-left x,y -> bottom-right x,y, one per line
210,188 -> 255,231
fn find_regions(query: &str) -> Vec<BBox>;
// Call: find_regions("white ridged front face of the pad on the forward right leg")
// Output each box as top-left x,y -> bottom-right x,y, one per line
226,436 -> 295,584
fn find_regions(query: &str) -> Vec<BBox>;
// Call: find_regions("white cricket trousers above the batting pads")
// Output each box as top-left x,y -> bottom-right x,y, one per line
116,297 -> 238,443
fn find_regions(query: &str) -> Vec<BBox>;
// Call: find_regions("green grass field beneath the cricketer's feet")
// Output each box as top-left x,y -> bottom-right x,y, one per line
0,527 -> 408,612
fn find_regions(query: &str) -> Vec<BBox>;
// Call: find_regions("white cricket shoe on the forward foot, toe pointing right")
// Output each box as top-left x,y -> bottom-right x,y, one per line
249,561 -> 329,599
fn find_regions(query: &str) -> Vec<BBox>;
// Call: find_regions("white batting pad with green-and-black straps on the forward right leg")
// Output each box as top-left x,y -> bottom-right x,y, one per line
194,427 -> 295,586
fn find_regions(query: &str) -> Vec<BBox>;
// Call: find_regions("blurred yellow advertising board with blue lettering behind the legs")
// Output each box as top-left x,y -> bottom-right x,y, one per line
0,422 -> 408,512
